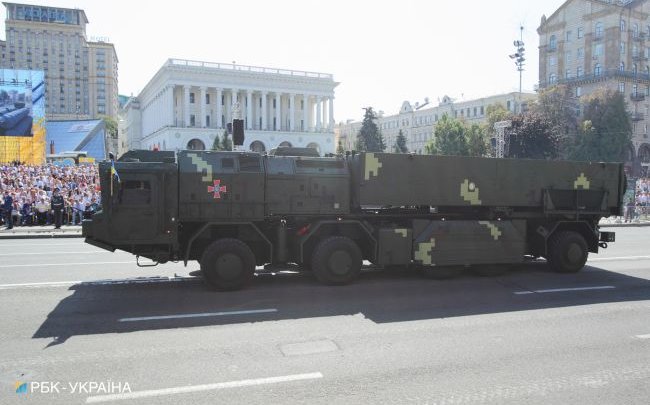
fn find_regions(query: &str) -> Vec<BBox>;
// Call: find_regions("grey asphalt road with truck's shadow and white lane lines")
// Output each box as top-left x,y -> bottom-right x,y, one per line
0,227 -> 650,404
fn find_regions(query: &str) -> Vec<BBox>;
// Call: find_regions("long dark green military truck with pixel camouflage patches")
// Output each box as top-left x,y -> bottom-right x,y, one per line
83,151 -> 625,290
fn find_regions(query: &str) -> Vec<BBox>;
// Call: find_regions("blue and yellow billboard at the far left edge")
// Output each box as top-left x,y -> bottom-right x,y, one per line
0,69 -> 45,165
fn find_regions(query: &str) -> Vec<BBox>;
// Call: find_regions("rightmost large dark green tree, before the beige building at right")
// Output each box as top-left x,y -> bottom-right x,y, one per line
571,90 -> 632,162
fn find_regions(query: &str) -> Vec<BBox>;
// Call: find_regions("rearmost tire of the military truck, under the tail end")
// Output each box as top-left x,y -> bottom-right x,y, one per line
546,231 -> 589,273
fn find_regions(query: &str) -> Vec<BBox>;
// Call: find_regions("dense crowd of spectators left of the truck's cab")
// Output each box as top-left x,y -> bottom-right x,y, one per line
0,163 -> 100,228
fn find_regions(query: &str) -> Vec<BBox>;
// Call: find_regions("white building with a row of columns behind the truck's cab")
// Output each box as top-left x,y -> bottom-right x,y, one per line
125,59 -> 338,154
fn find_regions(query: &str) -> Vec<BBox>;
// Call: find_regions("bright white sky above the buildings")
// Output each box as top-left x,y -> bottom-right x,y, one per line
0,0 -> 564,122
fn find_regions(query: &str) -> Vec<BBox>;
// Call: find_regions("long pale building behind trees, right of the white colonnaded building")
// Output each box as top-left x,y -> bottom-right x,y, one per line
336,92 -> 537,154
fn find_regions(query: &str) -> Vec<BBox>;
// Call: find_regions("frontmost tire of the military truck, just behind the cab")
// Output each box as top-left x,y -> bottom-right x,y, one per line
201,238 -> 255,291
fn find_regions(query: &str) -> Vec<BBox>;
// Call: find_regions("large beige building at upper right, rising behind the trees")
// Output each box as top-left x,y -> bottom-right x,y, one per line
537,0 -> 650,174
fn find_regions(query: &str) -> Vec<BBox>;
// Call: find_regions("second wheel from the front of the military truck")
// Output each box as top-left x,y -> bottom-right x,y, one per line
311,236 -> 361,285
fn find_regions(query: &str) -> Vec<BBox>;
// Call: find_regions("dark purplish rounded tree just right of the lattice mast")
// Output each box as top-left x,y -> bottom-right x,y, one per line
508,111 -> 559,159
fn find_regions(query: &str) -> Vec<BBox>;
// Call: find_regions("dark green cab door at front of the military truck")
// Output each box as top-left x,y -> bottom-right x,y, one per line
109,170 -> 162,243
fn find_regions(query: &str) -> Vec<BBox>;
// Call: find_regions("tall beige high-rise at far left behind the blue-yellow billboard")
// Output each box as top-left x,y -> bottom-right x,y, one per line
0,3 -> 118,120
